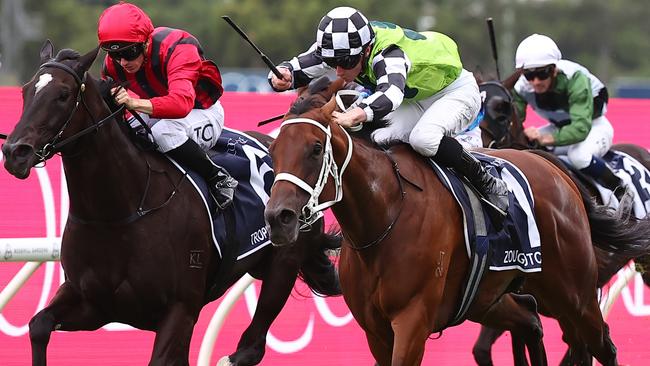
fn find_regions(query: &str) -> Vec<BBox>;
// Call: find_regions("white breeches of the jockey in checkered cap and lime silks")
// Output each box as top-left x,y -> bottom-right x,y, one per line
372,70 -> 482,156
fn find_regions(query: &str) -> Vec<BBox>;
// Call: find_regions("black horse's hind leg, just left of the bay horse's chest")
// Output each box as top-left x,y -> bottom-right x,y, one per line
228,252 -> 298,365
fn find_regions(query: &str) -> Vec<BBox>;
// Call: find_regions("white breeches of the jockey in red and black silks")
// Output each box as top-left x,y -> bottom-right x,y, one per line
130,101 -> 224,152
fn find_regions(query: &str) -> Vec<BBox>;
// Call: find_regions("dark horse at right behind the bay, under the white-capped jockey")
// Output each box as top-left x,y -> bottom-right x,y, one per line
472,72 -> 650,366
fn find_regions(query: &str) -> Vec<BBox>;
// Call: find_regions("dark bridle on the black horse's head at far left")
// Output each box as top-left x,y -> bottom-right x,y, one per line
35,61 -> 125,162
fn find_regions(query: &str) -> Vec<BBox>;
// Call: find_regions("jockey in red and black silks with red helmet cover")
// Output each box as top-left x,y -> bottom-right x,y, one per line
97,2 -> 237,208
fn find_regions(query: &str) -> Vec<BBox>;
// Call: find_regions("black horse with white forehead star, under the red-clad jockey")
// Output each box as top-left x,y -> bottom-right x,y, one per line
2,41 -> 340,365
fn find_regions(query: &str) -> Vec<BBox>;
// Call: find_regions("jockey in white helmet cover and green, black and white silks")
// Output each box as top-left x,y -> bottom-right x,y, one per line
513,34 -> 623,197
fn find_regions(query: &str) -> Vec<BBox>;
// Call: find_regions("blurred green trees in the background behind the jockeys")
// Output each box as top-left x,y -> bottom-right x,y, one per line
0,0 -> 650,98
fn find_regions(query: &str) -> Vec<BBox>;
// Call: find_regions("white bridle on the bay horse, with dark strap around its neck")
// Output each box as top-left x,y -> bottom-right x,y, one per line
274,118 -> 406,251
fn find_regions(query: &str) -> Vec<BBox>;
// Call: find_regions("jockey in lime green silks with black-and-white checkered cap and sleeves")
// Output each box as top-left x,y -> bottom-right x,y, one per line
269,7 -> 508,211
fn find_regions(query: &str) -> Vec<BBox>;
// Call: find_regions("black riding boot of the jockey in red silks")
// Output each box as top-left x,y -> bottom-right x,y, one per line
167,139 -> 238,209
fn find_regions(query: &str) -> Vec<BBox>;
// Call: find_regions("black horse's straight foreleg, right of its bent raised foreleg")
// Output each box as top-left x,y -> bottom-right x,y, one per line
149,302 -> 198,366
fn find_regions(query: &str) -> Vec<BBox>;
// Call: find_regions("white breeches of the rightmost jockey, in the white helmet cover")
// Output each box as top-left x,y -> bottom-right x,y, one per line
539,116 -> 614,169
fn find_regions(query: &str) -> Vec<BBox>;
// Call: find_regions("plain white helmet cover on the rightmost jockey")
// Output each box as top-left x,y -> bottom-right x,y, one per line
515,33 -> 562,69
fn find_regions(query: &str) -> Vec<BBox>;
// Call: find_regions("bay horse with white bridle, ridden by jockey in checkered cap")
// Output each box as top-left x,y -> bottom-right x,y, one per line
265,79 -> 650,366
